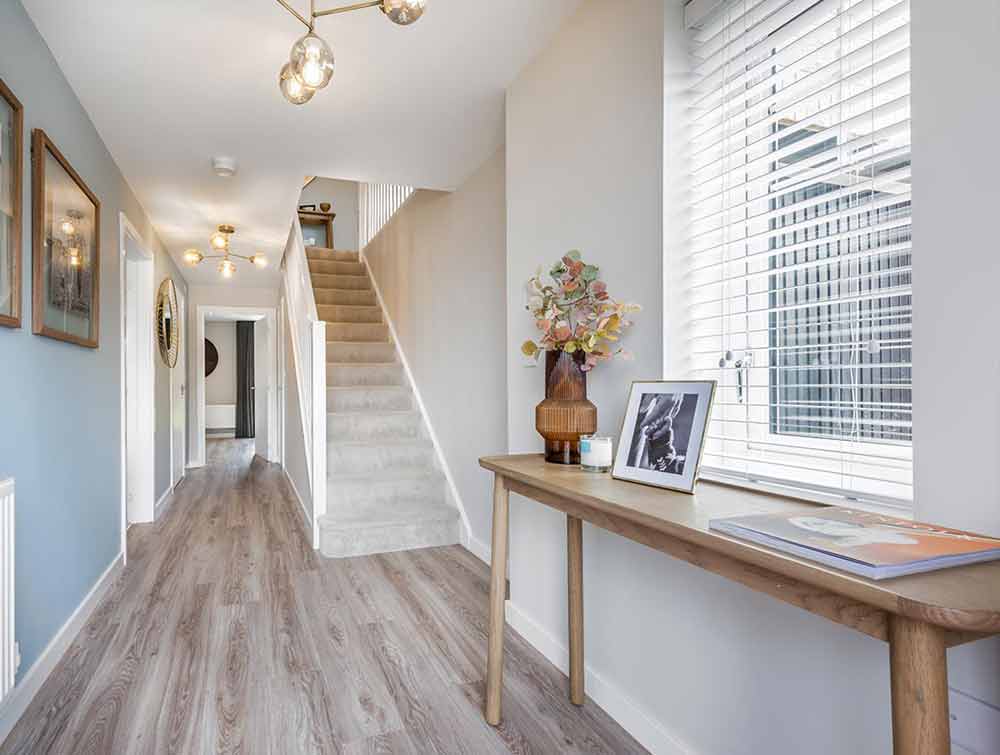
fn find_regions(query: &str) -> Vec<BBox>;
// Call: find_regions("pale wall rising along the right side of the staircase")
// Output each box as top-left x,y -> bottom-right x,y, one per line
365,150 -> 507,542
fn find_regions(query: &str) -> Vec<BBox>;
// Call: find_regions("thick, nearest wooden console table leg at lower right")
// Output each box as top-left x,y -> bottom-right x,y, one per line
889,616 -> 951,755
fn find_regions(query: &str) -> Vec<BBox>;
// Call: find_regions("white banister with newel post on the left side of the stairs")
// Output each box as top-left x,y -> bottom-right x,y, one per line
281,215 -> 326,547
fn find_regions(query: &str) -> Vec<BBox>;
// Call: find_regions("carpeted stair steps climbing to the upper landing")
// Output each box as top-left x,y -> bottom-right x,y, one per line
306,247 -> 459,558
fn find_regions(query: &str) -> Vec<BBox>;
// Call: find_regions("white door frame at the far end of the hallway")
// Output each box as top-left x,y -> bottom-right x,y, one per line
188,304 -> 281,467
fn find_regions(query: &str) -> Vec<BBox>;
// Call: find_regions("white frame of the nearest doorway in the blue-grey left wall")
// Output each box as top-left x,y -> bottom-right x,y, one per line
118,212 -> 156,558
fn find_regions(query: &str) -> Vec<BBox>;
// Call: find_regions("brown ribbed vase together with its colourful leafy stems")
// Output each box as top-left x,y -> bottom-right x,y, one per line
521,251 -> 639,464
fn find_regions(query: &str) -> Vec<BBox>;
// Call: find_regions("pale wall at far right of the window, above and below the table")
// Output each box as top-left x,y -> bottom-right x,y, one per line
911,0 -> 1000,716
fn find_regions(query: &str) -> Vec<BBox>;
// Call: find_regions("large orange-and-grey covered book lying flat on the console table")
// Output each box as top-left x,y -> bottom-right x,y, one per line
708,507 -> 1000,579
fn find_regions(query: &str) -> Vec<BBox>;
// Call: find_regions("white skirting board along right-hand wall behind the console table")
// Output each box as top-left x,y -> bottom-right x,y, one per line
467,535 -> 695,755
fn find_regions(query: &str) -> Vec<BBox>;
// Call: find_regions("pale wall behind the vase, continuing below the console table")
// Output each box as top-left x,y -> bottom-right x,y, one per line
508,0 -> 891,755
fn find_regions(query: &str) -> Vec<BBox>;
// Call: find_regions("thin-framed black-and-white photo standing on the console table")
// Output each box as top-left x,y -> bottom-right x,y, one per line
611,380 -> 716,493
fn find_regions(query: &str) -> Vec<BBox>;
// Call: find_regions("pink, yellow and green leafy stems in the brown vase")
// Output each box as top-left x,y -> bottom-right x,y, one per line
521,250 -> 641,372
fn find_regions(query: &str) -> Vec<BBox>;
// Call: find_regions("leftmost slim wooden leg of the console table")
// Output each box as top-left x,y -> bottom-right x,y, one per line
486,475 -> 510,726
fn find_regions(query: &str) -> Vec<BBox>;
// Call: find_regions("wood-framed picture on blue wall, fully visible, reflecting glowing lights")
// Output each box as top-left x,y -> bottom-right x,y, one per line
31,129 -> 101,349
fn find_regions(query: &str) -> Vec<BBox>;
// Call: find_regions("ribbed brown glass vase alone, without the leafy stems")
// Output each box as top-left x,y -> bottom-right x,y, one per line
535,351 -> 597,464
